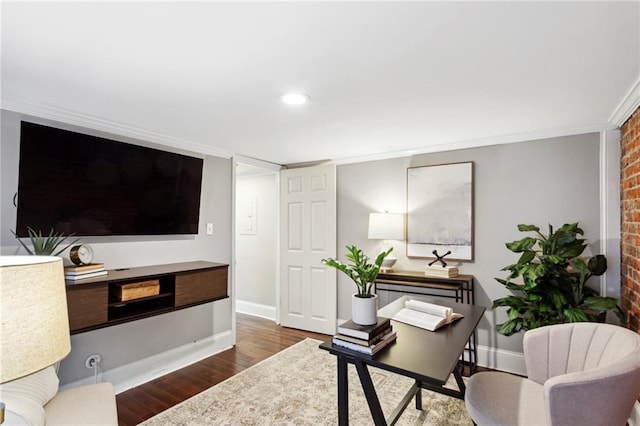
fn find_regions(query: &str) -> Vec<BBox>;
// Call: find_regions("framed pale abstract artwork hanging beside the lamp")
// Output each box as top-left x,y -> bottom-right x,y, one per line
407,161 -> 473,261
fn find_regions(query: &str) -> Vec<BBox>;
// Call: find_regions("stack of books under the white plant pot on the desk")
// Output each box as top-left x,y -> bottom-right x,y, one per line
333,317 -> 396,355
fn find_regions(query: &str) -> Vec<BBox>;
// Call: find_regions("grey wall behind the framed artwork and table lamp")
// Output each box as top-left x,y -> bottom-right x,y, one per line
337,134 -> 604,352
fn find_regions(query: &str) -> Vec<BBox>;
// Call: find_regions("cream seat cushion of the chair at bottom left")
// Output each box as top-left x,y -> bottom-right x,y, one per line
44,383 -> 118,426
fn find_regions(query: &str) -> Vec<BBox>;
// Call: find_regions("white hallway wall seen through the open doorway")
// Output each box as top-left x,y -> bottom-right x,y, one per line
236,171 -> 278,319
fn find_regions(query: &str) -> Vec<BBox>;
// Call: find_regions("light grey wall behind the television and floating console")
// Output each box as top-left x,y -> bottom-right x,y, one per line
0,111 -> 231,385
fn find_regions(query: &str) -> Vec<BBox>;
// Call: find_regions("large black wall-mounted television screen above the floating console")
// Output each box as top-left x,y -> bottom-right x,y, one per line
16,121 -> 203,237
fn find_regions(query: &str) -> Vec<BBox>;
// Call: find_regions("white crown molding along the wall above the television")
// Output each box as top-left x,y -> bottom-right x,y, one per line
0,96 -> 233,158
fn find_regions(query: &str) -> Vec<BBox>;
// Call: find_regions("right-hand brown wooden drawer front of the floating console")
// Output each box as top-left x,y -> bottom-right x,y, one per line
175,267 -> 228,307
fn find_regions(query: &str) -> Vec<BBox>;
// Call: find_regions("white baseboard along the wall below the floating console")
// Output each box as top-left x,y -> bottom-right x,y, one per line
60,330 -> 233,394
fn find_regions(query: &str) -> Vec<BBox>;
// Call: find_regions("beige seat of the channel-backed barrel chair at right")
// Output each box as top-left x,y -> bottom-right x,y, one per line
465,372 -> 547,426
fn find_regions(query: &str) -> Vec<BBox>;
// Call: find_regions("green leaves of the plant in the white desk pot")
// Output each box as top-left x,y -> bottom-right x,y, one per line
322,246 -> 393,297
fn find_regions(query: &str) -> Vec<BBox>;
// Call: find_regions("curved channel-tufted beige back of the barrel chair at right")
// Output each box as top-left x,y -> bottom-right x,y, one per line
525,323 -> 640,426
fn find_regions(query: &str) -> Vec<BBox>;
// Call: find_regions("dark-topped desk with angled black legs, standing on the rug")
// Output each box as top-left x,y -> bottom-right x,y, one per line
320,296 -> 485,426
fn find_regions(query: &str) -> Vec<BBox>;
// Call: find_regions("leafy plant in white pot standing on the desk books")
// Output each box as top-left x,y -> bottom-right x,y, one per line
322,246 -> 393,325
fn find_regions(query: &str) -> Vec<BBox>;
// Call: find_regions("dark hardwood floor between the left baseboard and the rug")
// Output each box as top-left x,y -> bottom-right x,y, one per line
116,314 -> 328,426
